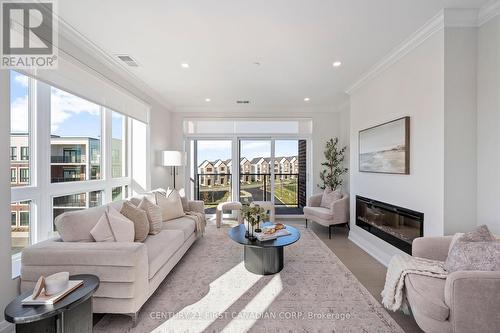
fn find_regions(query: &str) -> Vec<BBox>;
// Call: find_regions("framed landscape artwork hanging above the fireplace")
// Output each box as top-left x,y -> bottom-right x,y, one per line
359,117 -> 410,175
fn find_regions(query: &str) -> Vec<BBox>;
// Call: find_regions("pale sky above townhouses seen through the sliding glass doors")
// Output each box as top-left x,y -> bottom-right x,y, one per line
198,140 -> 298,164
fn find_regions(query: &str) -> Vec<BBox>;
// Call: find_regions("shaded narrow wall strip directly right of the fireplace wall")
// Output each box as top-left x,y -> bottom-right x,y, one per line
443,27 -> 477,235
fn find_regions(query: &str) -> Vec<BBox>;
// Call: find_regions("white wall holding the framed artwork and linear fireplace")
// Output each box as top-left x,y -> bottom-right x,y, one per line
350,31 -> 444,263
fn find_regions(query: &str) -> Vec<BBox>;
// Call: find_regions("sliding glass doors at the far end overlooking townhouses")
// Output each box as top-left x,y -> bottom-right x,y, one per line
190,137 -> 307,215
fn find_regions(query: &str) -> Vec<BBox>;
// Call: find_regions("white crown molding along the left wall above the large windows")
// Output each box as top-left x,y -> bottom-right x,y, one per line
57,16 -> 174,112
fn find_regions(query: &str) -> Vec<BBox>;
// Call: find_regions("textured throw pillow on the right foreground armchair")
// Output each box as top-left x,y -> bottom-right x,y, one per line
444,241 -> 500,273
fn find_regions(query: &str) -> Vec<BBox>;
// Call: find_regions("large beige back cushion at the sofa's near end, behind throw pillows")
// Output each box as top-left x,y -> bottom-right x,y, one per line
54,201 -> 123,242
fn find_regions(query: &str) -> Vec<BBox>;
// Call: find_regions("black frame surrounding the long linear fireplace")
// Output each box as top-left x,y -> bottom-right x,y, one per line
356,195 -> 424,255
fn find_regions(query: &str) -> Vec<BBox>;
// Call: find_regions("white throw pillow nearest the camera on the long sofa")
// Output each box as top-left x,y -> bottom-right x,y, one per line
90,207 -> 134,242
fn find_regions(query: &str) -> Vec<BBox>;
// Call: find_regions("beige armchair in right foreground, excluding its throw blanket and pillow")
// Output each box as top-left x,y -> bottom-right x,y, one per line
405,236 -> 500,333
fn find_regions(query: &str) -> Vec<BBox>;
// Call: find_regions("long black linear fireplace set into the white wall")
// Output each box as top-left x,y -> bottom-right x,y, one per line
356,195 -> 424,254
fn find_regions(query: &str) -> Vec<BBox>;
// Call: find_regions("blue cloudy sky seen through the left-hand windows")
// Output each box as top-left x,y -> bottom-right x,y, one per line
10,71 -> 124,139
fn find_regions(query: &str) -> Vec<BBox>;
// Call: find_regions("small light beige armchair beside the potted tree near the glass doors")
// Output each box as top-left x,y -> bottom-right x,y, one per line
304,193 -> 349,238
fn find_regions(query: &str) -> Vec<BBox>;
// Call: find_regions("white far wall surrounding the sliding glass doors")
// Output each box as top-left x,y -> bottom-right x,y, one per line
171,110 -> 348,197
